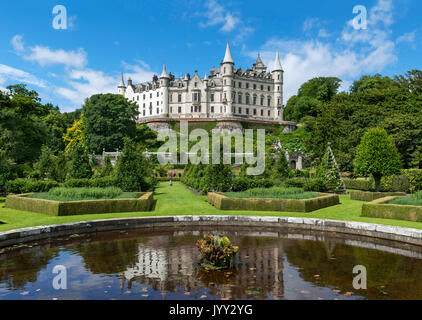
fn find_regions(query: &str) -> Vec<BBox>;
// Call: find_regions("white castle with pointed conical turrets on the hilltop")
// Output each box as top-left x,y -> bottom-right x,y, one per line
118,42 -> 284,122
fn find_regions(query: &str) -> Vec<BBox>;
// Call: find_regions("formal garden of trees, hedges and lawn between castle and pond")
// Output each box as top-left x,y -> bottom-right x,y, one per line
0,71 -> 422,230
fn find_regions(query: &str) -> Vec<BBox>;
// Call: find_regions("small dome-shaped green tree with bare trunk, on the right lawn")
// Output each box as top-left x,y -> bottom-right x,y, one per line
354,128 -> 401,192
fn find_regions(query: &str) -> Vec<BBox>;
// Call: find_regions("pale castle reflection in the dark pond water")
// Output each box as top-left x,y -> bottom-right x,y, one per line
121,232 -> 284,299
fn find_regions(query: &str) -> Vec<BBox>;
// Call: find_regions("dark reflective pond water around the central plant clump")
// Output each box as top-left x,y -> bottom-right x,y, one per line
0,228 -> 422,300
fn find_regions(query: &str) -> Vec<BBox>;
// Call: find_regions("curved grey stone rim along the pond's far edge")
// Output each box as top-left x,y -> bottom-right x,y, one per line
0,215 -> 422,248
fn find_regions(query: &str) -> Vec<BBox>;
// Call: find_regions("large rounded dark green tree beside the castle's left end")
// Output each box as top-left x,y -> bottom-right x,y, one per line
82,94 -> 138,154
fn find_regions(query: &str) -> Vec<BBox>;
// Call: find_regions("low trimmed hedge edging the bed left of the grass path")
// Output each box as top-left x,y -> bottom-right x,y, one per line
5,192 -> 154,216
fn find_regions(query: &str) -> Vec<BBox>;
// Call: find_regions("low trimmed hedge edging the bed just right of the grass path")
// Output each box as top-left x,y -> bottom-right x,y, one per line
208,192 -> 340,212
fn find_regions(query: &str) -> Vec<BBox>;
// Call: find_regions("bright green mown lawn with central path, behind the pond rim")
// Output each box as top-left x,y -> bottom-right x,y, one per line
0,182 -> 422,231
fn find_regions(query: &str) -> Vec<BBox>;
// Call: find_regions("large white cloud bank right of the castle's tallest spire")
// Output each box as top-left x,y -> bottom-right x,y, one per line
247,0 -> 400,102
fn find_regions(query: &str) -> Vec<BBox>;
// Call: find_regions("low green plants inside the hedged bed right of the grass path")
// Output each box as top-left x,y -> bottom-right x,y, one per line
224,187 -> 319,199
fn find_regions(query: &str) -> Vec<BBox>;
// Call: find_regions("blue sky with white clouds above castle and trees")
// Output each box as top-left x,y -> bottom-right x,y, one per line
0,0 -> 422,111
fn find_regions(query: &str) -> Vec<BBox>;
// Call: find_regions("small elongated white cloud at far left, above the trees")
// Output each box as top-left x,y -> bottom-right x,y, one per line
24,46 -> 88,68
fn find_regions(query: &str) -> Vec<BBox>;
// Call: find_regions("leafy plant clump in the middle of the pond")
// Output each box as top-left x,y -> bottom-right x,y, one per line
196,234 -> 239,271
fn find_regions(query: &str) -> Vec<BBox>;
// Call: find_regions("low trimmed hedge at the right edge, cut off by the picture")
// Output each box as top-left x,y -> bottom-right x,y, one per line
361,197 -> 422,222
